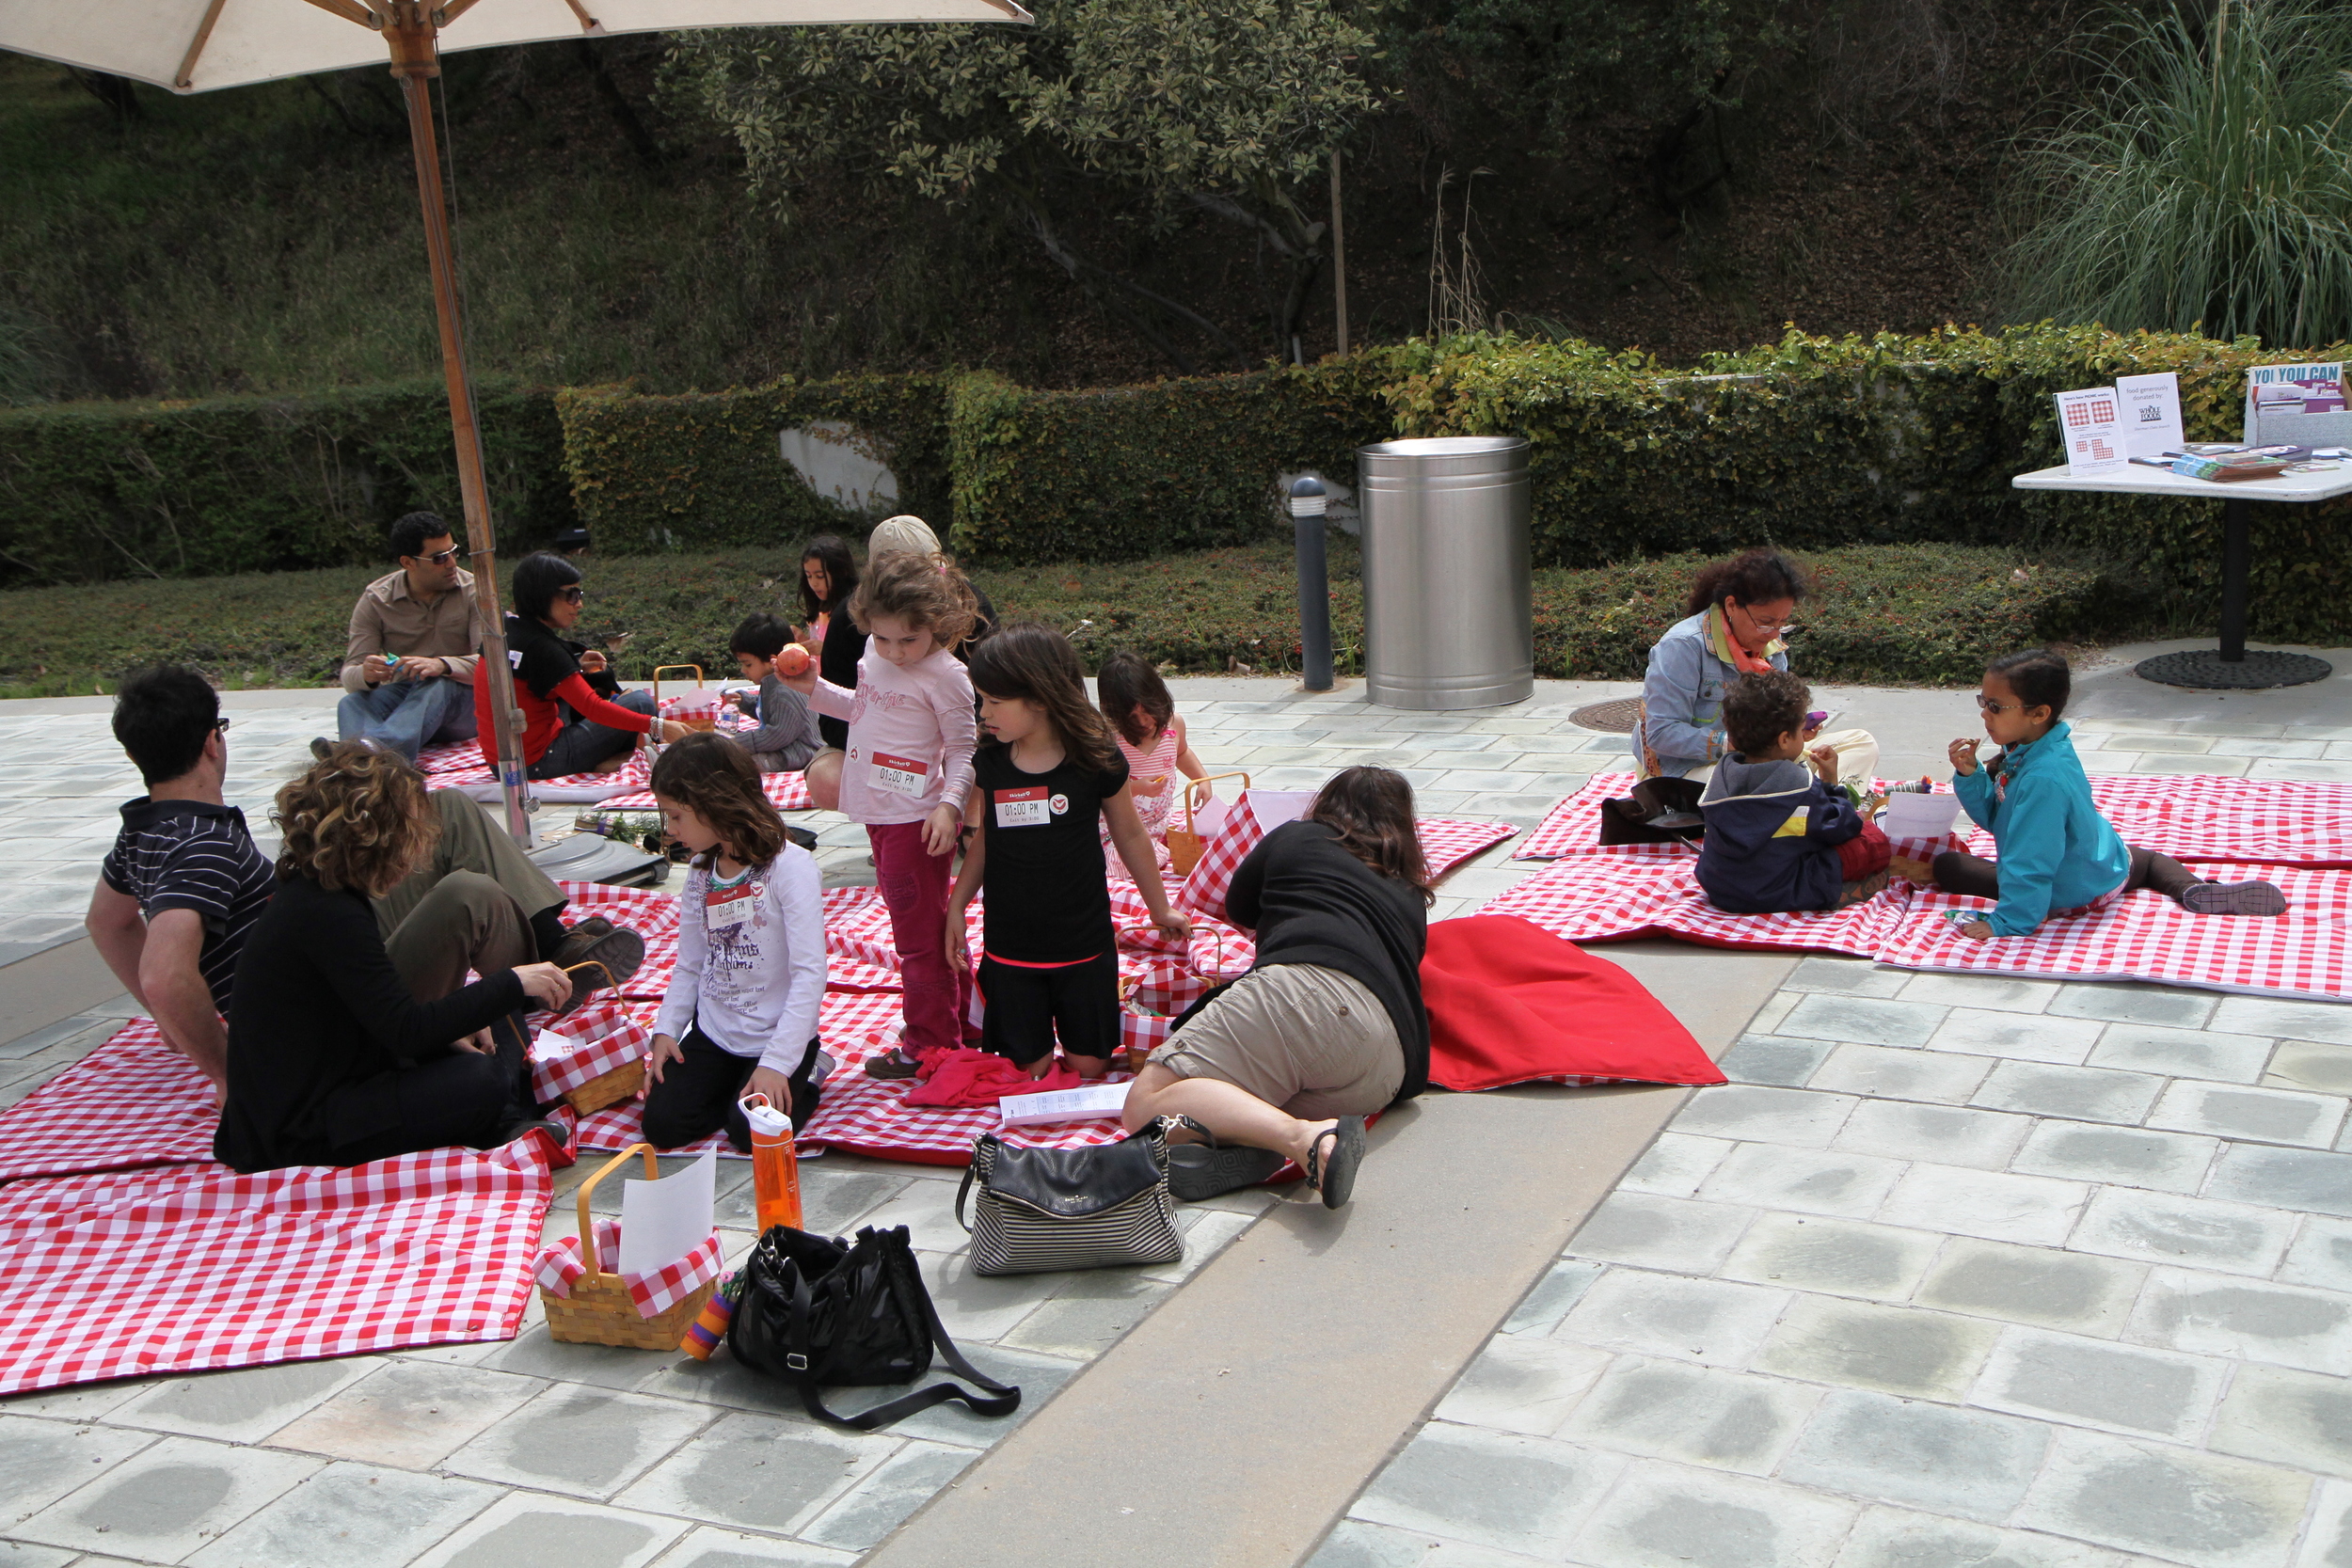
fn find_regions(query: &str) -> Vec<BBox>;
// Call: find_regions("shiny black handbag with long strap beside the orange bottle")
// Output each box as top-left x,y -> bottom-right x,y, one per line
727,1225 -> 1021,1432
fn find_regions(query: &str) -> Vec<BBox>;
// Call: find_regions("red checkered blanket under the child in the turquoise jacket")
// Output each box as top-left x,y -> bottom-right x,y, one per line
1877,863 -> 2352,1002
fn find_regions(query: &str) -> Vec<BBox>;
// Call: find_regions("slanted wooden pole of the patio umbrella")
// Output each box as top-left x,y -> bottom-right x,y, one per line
379,0 -> 532,844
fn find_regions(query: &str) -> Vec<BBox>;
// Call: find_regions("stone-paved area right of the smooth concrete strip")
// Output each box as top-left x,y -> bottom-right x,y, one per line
1312,959 -> 2352,1568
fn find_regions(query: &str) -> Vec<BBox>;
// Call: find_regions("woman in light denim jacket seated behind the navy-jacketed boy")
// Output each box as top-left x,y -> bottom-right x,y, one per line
1632,550 -> 1880,787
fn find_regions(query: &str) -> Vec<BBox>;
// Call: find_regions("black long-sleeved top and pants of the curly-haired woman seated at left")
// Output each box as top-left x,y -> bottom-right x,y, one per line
212,877 -> 525,1171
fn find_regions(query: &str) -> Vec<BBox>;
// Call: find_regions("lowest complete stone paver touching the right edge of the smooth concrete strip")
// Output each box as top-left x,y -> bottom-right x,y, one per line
1348,1422 -> 1626,1561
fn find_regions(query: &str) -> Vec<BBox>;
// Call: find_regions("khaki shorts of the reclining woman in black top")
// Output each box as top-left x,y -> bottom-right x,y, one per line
1151,964 -> 1405,1121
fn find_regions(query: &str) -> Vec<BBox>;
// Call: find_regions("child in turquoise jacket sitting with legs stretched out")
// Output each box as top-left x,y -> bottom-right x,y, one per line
1936,649 -> 2286,938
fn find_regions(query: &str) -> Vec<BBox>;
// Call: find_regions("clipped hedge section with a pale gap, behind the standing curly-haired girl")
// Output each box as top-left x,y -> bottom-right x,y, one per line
558,376 -> 950,552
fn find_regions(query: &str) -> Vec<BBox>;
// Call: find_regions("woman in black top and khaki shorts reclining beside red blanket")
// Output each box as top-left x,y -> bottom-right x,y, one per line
1124,768 -> 1433,1209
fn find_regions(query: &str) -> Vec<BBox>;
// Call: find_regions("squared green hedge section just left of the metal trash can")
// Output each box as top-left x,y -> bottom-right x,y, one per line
948,355 -> 1388,562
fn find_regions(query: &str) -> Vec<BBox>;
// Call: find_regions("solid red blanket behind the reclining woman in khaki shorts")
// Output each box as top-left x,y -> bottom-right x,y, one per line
1421,914 -> 1724,1091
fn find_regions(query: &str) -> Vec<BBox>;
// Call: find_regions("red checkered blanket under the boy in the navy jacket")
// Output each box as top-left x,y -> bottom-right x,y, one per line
1477,851 -> 1913,959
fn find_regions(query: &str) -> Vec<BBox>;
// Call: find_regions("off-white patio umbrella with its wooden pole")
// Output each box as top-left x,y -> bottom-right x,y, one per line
0,0 -> 1030,842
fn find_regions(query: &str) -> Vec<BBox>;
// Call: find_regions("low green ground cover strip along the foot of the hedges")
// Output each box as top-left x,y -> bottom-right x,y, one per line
0,545 -> 2153,698
